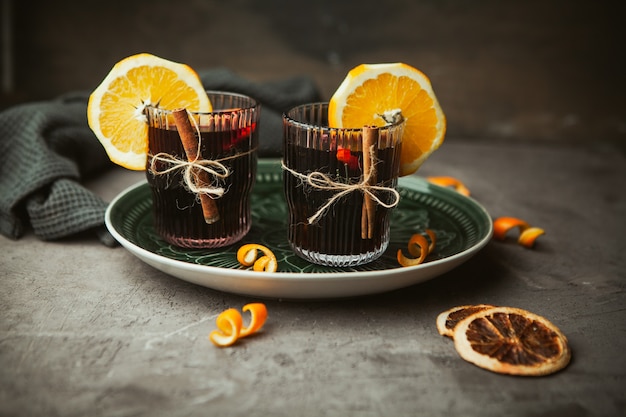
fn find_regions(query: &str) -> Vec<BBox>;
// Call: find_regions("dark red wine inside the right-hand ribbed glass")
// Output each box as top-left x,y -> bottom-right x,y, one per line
284,141 -> 400,265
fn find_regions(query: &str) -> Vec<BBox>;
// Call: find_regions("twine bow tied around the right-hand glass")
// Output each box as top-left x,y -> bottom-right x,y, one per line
281,148 -> 400,224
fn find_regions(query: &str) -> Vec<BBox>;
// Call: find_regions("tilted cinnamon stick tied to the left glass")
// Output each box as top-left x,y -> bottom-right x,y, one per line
173,109 -> 220,224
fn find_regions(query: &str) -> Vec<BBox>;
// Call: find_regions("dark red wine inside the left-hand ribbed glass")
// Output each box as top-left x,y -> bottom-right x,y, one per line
147,124 -> 258,248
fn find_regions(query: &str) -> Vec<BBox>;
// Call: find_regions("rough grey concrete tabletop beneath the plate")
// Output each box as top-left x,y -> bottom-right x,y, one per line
0,138 -> 626,417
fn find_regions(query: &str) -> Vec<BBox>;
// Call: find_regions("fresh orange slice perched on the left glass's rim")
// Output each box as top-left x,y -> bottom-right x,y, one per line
87,53 -> 212,170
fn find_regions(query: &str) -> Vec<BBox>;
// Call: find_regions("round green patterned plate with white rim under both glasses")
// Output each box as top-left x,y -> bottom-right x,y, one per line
106,160 -> 492,299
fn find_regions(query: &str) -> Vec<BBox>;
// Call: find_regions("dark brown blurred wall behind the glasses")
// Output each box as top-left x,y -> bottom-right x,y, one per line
0,0 -> 626,145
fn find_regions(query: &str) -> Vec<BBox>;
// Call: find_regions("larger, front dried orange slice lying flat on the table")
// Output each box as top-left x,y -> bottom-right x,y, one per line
453,307 -> 571,376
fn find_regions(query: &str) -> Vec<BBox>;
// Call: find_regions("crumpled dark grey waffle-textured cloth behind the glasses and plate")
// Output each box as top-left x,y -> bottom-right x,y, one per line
0,68 -> 320,246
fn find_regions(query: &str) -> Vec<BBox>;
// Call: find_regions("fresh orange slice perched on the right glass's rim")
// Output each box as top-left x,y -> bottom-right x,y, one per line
328,63 -> 446,176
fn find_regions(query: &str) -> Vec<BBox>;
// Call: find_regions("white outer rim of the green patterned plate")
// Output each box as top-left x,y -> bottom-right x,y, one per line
105,178 -> 493,299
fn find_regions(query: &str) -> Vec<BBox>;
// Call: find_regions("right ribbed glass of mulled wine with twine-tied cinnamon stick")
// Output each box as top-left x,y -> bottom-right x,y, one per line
283,103 -> 404,267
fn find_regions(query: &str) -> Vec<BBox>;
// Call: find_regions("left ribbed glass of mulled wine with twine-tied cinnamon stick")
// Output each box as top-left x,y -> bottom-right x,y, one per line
145,91 -> 260,248
